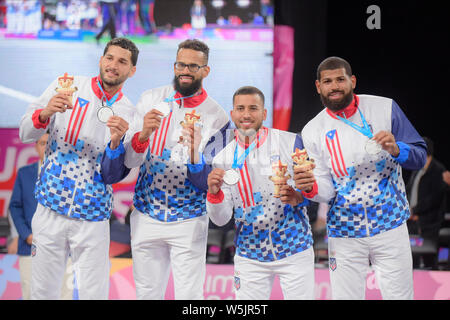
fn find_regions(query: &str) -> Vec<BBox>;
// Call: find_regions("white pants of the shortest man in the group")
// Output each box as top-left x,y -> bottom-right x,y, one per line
234,247 -> 315,300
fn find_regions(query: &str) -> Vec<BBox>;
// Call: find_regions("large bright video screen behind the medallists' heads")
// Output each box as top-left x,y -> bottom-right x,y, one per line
0,0 -> 273,128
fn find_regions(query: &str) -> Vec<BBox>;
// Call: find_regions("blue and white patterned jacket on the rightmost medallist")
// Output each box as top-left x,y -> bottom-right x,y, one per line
302,95 -> 426,238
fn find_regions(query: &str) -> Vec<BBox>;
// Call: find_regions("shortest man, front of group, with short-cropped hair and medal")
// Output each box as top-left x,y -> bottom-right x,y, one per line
207,86 -> 314,300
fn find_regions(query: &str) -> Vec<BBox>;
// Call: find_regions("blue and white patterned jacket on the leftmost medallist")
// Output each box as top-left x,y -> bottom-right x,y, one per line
19,76 -> 135,221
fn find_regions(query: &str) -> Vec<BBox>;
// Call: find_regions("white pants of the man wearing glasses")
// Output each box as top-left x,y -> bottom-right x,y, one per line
130,210 -> 208,300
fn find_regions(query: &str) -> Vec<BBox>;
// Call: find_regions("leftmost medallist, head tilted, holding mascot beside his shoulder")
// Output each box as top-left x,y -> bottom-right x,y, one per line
19,38 -> 139,299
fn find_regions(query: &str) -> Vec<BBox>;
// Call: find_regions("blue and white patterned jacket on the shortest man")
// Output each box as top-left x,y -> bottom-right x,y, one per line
207,128 -> 313,262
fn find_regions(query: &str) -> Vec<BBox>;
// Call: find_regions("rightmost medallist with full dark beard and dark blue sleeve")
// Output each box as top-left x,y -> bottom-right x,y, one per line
294,57 -> 426,299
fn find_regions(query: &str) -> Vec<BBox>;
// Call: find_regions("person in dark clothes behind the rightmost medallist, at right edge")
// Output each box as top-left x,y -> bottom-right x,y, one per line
406,137 -> 446,269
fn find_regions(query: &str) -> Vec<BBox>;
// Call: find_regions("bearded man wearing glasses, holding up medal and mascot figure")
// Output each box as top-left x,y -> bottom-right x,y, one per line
102,39 -> 229,300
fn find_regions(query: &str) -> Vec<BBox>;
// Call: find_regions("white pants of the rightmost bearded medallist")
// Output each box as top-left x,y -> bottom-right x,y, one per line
328,223 -> 414,300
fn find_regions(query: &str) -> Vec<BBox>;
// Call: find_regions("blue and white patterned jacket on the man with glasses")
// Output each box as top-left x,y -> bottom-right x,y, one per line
102,85 -> 229,222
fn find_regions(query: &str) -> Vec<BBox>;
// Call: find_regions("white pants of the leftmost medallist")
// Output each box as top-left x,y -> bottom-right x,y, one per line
31,204 -> 110,300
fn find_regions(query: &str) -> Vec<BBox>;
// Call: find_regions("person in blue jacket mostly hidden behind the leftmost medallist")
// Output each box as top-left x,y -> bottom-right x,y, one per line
8,133 -> 73,300
